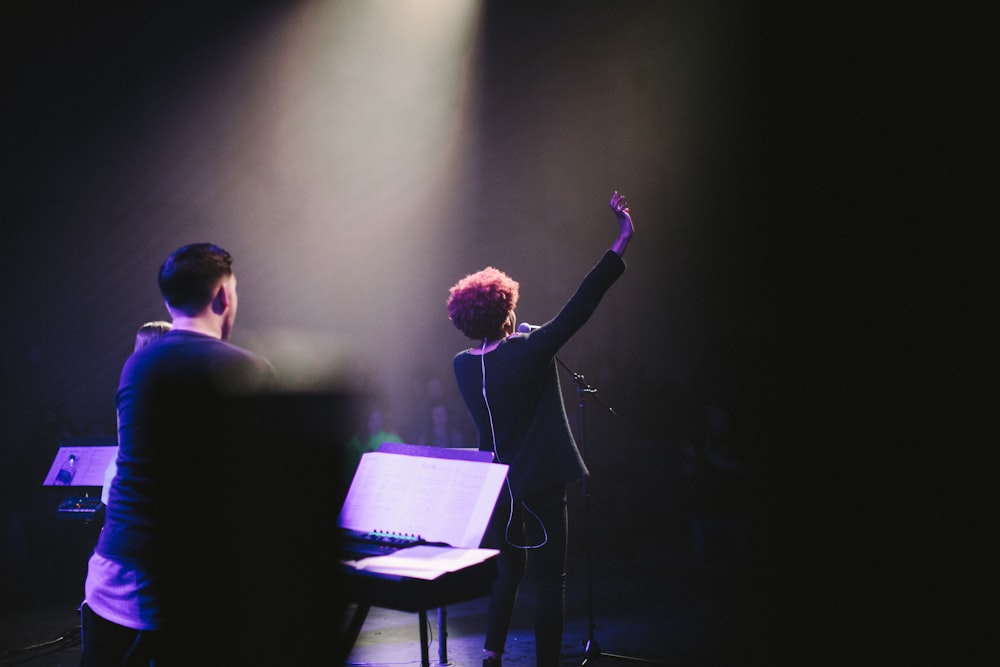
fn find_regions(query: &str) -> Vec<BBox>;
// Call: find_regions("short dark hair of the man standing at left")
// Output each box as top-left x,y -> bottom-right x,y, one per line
159,243 -> 233,312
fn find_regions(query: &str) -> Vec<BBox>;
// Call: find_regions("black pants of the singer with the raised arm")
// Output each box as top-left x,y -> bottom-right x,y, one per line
485,486 -> 568,667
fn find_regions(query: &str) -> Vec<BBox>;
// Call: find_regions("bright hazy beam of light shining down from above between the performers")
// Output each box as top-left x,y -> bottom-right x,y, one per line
135,0 -> 479,396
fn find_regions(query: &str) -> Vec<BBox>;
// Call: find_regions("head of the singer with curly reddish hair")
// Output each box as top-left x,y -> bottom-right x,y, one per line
448,266 -> 520,341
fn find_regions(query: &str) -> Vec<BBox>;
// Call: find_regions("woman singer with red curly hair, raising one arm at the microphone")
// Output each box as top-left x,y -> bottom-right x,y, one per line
448,192 -> 634,667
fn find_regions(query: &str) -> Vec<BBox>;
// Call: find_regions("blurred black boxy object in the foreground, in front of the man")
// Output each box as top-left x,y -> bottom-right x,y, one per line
154,391 -> 352,665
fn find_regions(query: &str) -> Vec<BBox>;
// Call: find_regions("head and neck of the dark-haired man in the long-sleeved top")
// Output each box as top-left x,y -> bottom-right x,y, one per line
159,243 -> 236,340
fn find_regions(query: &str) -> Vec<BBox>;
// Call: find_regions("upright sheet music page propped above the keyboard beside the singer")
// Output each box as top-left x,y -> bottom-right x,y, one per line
340,452 -> 507,549
